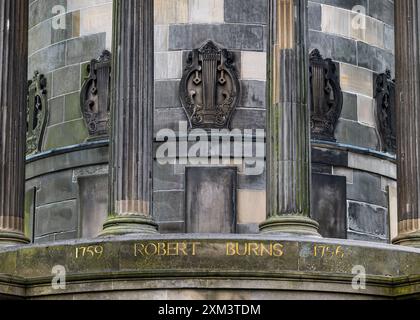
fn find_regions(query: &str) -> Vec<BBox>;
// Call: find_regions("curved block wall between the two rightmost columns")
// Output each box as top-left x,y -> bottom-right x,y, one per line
309,0 -> 397,241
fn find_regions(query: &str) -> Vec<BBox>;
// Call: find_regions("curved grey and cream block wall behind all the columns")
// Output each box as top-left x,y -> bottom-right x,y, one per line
26,0 -> 396,242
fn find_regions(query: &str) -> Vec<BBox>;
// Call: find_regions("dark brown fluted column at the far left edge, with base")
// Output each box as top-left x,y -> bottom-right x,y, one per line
0,0 -> 29,246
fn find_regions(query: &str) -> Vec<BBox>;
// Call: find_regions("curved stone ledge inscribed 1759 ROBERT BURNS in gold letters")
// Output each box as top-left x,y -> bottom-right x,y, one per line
0,235 -> 420,299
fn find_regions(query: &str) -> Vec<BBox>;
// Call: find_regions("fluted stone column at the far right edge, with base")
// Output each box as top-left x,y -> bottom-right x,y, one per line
394,0 -> 420,247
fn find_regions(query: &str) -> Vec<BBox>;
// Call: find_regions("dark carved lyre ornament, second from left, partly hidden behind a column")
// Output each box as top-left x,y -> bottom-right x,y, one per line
80,50 -> 111,140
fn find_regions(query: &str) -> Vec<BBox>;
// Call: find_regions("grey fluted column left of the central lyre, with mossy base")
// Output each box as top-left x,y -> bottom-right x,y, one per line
102,0 -> 157,235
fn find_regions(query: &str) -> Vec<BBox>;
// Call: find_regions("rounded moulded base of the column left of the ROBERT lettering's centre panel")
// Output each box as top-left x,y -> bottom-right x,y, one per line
99,216 -> 158,237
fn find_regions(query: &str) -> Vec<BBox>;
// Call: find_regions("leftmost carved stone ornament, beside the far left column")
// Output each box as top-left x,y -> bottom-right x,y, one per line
26,71 -> 49,155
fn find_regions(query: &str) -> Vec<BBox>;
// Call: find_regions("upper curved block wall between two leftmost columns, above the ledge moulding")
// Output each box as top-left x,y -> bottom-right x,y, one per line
28,0 -> 112,151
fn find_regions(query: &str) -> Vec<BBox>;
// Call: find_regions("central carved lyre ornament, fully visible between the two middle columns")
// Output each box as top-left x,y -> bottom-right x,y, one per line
179,41 -> 240,129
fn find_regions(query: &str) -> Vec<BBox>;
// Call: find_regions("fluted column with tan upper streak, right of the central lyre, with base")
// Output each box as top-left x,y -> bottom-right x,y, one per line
260,0 -> 319,235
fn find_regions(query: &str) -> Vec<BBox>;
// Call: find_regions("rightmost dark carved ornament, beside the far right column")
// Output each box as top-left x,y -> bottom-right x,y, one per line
375,70 -> 397,153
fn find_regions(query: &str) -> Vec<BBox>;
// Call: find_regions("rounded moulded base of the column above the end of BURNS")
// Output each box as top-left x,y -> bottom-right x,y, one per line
260,216 -> 321,237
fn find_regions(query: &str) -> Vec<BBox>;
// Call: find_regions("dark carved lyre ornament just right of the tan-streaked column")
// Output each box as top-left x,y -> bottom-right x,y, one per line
309,49 -> 343,142
